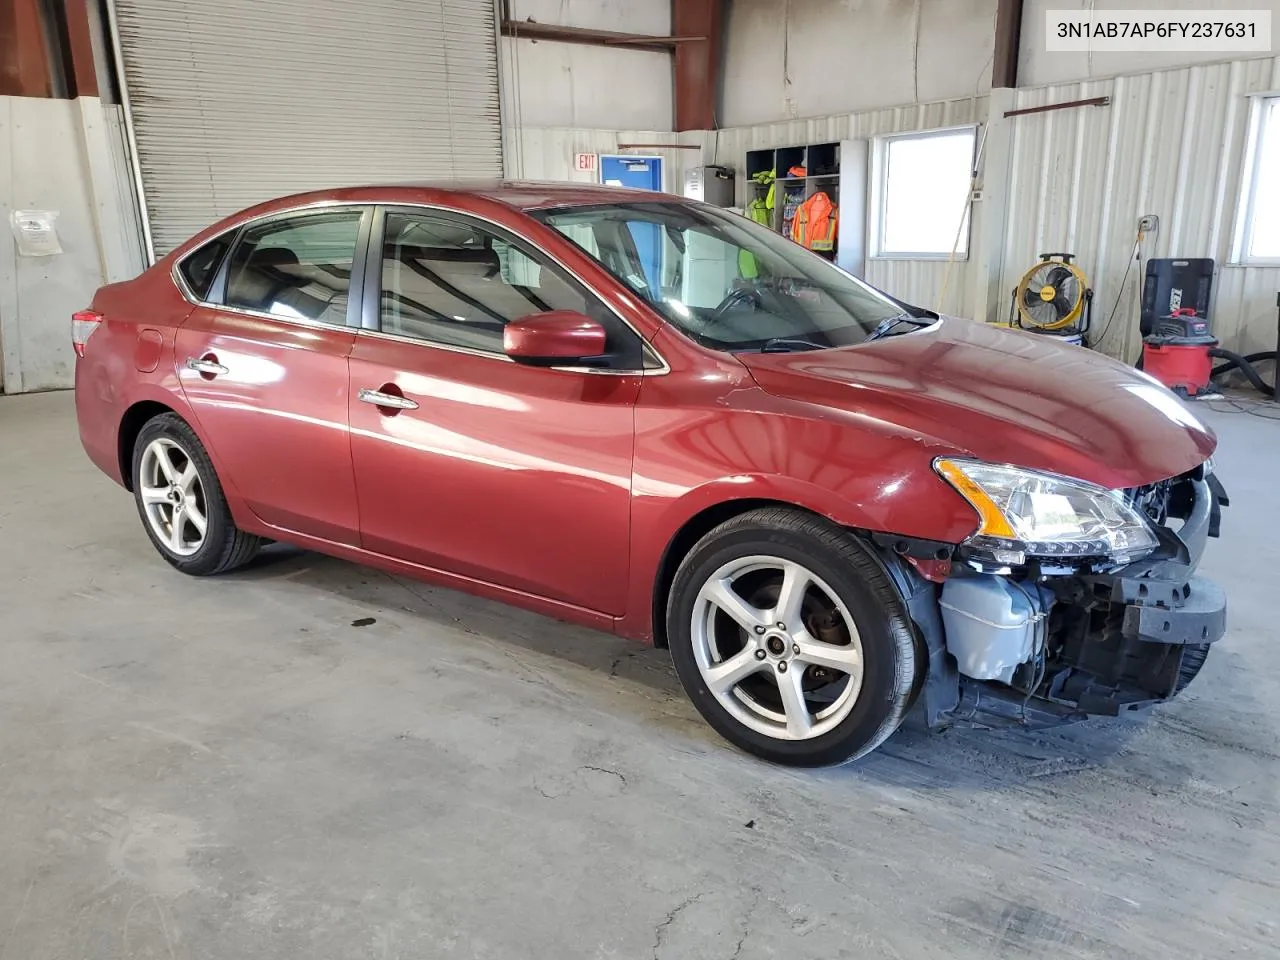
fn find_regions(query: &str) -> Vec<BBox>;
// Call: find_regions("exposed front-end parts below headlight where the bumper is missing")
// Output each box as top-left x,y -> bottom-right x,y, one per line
882,468 -> 1228,727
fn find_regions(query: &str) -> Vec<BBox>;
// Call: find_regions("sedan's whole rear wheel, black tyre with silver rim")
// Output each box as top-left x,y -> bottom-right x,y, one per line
133,413 -> 261,576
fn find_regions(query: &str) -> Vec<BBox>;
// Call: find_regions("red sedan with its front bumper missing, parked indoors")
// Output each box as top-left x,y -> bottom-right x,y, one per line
73,183 -> 1225,764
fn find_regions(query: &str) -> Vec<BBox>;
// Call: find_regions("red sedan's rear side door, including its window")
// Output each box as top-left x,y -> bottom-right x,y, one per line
175,206 -> 372,545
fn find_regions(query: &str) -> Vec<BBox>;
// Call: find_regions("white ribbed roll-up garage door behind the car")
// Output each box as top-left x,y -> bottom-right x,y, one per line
111,0 -> 502,256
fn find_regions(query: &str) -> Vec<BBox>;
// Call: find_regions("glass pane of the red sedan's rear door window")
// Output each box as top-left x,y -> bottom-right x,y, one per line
224,209 -> 364,326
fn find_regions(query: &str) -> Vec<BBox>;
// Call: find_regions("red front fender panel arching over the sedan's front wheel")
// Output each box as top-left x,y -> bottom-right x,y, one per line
617,360 -> 978,639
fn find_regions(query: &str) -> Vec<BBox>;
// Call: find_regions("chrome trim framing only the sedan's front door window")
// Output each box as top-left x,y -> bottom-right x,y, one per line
358,202 -> 671,376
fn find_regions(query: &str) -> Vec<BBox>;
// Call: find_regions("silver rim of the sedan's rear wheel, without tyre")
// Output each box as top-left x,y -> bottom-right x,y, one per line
138,436 -> 209,557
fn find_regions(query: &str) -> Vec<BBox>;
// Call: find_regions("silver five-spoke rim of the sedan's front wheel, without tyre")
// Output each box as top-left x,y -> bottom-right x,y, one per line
691,556 -> 863,740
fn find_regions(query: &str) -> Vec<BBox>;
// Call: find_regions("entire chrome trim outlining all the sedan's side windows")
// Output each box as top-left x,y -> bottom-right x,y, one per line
169,200 -> 671,376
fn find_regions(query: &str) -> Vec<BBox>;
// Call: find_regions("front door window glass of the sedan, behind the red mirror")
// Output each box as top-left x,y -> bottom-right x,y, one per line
380,211 -> 641,369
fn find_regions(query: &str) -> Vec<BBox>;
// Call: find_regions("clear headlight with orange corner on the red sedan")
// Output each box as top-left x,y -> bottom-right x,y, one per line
933,460 -> 1158,564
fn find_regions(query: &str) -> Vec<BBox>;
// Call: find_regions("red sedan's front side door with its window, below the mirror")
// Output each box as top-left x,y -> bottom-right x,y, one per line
351,209 -> 645,614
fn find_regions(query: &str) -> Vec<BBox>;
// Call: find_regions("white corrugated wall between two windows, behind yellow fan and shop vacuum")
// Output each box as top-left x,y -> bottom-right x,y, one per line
988,58 -> 1280,361
